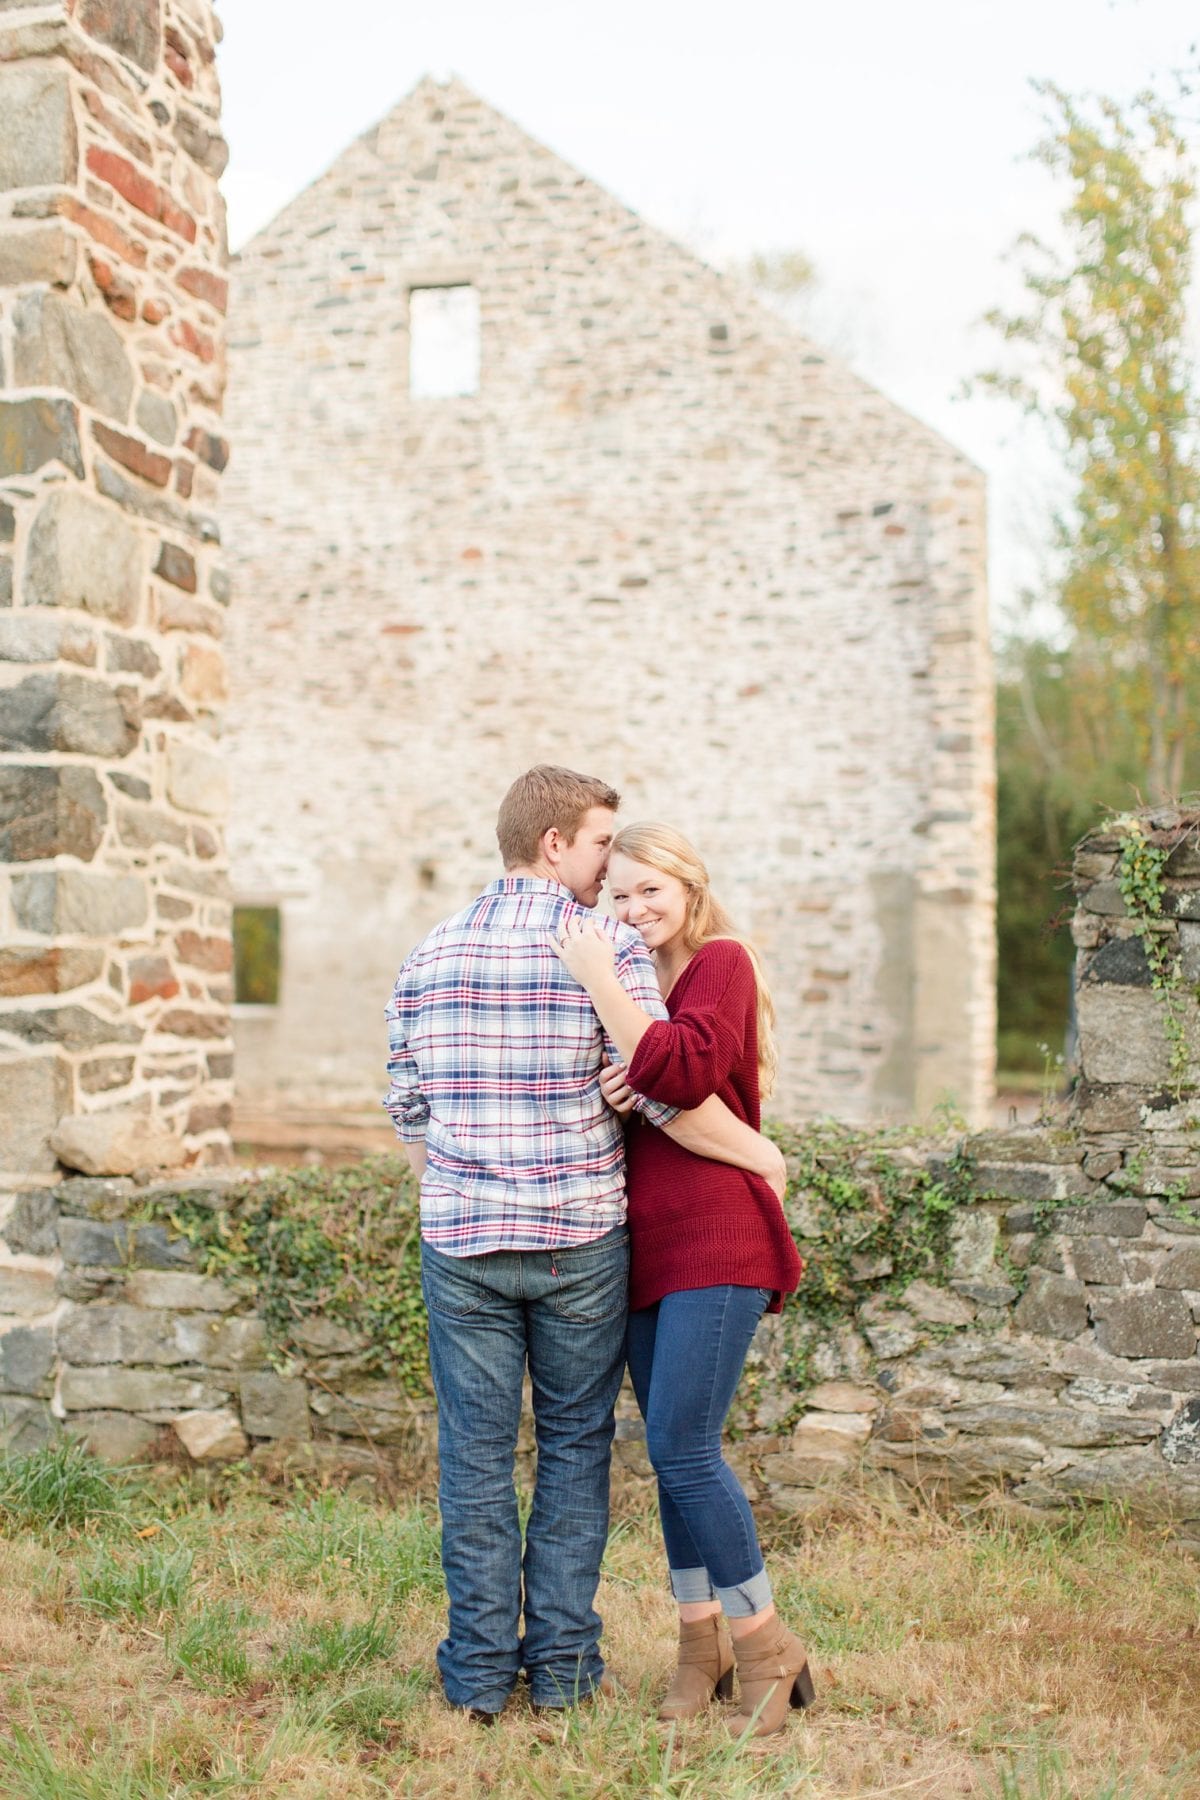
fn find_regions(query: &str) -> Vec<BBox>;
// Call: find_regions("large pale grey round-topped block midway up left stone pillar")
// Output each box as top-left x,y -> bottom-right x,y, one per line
23,488 -> 144,625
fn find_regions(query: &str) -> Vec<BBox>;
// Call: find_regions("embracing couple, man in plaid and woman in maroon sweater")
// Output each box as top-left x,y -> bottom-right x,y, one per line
385,765 -> 813,1735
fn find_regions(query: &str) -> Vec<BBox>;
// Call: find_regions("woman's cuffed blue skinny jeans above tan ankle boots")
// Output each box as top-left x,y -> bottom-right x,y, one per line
626,1285 -> 770,1618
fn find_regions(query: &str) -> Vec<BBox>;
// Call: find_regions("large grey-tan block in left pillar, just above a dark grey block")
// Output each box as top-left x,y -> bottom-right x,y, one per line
13,288 -> 133,419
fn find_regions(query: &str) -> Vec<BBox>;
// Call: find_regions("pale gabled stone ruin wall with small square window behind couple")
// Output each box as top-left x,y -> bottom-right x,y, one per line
223,81 -> 993,1121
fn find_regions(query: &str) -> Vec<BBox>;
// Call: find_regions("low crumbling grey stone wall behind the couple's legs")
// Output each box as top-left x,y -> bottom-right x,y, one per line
0,814 -> 1200,1550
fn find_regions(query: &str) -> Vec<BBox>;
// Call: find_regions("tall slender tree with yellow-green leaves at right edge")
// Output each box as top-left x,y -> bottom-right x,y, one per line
982,85 -> 1200,799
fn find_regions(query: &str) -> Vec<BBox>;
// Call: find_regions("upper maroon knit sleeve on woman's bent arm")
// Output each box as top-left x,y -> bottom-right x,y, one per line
630,940 -> 754,1109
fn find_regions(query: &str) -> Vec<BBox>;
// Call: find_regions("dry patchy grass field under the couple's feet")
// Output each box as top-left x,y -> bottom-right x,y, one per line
0,1449 -> 1200,1800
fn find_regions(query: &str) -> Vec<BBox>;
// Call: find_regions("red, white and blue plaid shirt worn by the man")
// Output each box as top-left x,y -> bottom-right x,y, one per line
383,875 -> 675,1256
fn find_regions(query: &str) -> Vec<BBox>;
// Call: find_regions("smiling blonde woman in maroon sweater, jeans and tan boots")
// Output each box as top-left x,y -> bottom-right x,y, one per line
558,824 -> 813,1737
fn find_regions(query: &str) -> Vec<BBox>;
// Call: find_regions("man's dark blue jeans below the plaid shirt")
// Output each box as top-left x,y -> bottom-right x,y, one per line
421,1226 -> 630,1712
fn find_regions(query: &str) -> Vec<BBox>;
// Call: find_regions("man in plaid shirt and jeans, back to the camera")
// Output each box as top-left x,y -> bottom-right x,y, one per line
385,765 -> 783,1721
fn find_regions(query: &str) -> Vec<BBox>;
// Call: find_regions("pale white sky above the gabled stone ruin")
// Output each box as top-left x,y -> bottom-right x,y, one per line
219,0 -> 1200,626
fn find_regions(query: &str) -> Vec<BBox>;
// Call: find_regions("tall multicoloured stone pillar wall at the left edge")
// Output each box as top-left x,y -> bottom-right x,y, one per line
0,0 -> 232,1180
